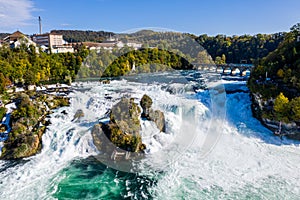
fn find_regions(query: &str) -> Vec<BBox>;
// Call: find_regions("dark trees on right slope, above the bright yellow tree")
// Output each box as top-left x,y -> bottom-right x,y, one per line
249,24 -> 300,98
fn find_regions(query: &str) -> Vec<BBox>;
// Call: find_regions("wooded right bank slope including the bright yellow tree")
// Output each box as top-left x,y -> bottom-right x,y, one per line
248,23 -> 300,124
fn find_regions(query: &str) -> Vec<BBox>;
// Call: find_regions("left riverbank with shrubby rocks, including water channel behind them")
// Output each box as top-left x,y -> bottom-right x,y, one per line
0,86 -> 70,160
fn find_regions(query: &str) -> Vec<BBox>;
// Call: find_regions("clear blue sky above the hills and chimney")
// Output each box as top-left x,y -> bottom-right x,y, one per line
0,0 -> 300,35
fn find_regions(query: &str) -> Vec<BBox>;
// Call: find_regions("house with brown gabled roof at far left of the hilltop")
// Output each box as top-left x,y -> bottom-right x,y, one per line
3,31 -> 36,48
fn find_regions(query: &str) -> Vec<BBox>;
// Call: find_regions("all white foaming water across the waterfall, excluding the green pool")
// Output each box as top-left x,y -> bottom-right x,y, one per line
0,74 -> 300,199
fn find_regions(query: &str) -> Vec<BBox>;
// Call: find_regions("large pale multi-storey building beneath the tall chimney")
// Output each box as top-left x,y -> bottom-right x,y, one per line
32,33 -> 74,53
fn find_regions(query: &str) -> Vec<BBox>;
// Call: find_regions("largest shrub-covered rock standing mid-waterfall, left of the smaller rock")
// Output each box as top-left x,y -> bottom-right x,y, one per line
92,98 -> 145,152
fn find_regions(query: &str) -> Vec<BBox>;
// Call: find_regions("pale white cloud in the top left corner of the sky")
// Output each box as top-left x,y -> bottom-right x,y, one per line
0,0 -> 34,31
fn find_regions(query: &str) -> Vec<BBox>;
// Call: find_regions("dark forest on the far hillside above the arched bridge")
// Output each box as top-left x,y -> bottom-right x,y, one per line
120,30 -> 285,63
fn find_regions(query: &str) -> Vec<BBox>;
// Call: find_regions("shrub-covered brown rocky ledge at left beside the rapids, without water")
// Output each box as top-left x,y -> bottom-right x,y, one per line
0,92 -> 69,160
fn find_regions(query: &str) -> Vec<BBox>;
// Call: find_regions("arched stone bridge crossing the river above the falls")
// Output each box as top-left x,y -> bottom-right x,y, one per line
191,63 -> 254,76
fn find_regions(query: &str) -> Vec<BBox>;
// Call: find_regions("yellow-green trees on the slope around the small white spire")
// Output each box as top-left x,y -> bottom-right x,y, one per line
78,47 -> 193,78
